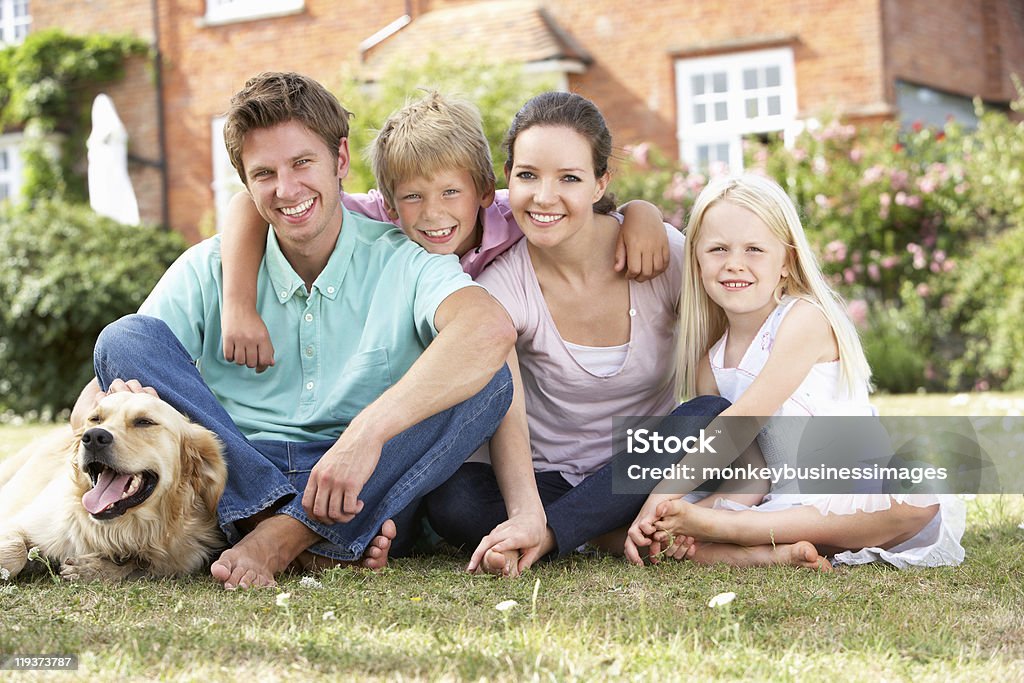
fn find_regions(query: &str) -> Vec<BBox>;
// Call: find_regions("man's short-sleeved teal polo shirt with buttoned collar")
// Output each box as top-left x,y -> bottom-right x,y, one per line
139,204 -> 473,441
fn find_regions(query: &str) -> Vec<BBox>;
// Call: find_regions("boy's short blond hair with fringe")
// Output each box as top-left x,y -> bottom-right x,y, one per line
370,91 -> 495,209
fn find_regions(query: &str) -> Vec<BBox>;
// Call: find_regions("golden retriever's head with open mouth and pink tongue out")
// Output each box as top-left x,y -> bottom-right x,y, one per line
75,391 -> 227,520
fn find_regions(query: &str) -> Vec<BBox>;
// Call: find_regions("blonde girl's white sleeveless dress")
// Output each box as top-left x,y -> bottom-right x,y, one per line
710,297 -> 967,568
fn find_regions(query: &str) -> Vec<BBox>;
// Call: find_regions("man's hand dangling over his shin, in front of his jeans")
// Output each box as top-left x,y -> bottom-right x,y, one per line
302,422 -> 384,524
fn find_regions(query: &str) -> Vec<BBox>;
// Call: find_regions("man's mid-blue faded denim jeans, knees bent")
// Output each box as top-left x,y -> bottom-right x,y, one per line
94,314 -> 512,560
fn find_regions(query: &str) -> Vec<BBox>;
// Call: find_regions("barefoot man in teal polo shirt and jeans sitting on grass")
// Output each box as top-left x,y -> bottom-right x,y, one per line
72,73 -> 515,589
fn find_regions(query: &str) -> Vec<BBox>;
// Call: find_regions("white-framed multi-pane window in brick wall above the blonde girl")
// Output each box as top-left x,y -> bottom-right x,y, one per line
676,47 -> 797,172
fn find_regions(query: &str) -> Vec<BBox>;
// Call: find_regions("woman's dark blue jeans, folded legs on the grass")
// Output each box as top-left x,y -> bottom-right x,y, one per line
425,396 -> 731,556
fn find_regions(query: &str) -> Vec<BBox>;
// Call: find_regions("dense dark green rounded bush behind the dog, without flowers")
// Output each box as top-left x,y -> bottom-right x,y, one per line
0,202 -> 185,414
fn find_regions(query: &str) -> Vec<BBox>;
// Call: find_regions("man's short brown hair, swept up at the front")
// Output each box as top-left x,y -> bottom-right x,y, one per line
224,72 -> 352,186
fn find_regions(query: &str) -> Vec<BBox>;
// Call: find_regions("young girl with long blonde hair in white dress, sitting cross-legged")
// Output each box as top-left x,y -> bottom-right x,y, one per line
627,175 -> 965,568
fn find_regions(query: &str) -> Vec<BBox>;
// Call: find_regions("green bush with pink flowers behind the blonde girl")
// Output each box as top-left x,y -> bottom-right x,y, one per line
612,81 -> 1024,391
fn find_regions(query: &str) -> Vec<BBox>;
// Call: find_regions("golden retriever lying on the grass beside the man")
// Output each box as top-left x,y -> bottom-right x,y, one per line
0,391 -> 227,581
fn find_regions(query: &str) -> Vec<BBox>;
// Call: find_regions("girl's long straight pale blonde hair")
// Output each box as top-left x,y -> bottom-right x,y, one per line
676,174 -> 871,398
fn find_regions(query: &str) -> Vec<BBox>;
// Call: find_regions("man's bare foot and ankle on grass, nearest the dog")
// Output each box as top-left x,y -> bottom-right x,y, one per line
210,515 -> 319,591
